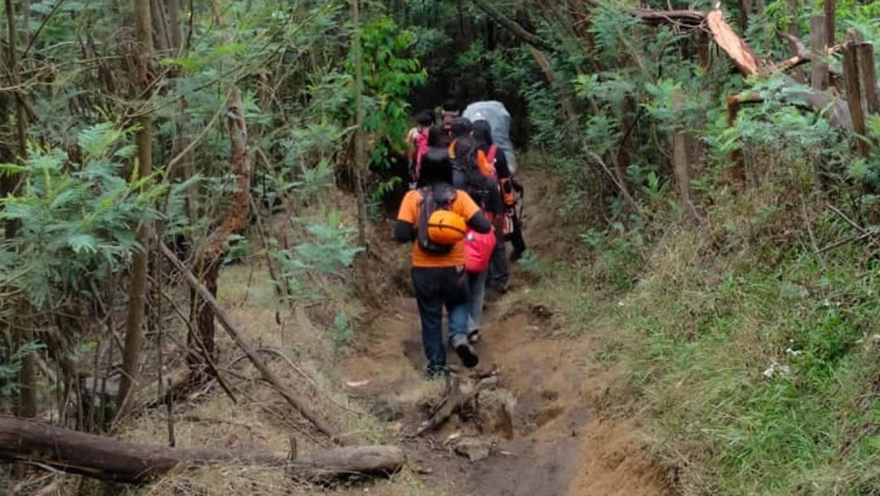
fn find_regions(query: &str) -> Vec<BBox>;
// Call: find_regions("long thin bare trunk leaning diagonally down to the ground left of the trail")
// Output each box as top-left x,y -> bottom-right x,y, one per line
159,243 -> 344,444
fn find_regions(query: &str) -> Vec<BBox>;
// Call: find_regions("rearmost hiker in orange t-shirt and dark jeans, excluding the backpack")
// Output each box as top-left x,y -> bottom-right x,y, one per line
394,148 -> 492,377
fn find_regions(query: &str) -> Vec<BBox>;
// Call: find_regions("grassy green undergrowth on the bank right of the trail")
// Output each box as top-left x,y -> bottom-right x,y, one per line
525,156 -> 880,496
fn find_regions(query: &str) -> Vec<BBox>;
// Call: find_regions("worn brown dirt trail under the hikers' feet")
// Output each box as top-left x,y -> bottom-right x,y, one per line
343,169 -> 673,496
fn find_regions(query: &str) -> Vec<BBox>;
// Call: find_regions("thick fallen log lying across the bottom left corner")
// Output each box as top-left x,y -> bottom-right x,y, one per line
0,417 -> 404,484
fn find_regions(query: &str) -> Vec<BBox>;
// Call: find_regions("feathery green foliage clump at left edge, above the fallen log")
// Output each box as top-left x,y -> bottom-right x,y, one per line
0,124 -> 165,310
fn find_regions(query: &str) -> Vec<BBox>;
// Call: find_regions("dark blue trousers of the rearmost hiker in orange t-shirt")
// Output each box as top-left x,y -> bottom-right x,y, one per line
412,267 -> 468,373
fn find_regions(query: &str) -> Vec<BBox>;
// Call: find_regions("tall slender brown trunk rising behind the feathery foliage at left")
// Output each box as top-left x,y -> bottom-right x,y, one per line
117,0 -> 153,409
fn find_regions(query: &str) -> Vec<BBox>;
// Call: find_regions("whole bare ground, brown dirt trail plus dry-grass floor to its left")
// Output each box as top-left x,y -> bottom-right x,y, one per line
108,170 -> 674,496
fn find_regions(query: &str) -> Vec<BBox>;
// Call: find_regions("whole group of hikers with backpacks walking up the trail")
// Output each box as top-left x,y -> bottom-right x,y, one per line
394,101 -> 526,377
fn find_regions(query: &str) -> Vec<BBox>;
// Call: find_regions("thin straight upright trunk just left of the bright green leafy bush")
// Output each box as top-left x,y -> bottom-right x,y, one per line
351,0 -> 367,247
